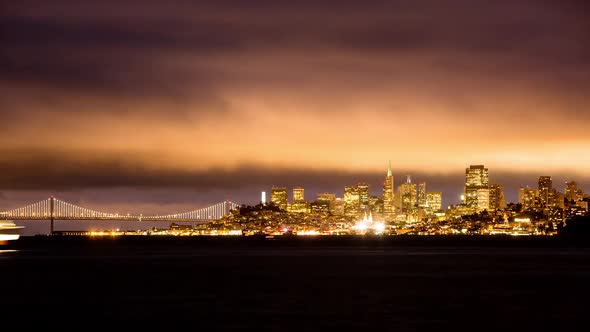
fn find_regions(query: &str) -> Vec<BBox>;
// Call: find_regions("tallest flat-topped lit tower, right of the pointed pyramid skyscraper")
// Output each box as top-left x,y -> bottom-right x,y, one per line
465,165 -> 489,211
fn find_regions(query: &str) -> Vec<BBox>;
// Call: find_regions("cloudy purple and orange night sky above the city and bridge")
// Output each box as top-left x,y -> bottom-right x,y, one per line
0,0 -> 590,213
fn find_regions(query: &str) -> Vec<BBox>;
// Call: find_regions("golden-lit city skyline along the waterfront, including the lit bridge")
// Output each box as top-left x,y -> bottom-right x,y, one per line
0,162 -> 590,235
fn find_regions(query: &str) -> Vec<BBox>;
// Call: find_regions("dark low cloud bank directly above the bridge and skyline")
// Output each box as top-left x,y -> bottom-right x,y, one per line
0,147 -> 590,211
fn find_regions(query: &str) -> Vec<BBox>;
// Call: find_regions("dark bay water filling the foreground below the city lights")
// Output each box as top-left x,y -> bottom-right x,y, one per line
0,237 -> 590,331
